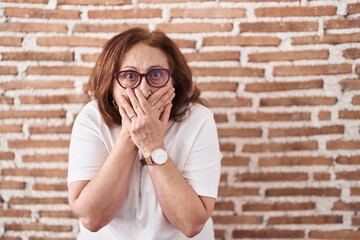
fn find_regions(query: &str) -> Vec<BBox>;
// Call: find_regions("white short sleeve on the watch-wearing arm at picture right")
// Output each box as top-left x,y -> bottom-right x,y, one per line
182,109 -> 222,198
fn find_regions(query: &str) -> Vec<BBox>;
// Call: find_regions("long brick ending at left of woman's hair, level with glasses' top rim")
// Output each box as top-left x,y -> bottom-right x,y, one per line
26,66 -> 92,76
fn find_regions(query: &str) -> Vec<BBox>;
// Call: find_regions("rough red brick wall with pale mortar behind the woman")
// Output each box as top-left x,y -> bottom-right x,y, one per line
0,0 -> 360,240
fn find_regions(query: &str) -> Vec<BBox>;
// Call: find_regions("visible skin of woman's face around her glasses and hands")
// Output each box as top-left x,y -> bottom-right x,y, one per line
113,43 -> 172,105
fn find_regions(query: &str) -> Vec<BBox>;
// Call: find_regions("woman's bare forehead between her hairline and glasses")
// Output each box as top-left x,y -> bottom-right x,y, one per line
121,43 -> 169,70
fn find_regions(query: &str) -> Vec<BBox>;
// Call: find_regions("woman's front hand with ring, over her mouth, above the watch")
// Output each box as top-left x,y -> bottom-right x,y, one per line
120,88 -> 172,157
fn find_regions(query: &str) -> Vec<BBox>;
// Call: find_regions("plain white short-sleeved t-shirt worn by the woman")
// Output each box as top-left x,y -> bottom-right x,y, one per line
68,101 -> 221,240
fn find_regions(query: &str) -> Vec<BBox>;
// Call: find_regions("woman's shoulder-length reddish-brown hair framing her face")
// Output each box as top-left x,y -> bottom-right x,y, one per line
87,28 -> 203,125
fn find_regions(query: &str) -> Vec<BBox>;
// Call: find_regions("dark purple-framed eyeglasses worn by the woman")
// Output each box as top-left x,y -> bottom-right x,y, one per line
114,68 -> 171,88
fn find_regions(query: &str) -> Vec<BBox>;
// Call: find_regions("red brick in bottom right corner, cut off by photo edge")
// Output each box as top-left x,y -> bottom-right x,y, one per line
309,230 -> 360,240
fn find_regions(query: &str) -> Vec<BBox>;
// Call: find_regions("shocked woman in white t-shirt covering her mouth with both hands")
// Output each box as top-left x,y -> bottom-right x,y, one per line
68,28 -> 221,240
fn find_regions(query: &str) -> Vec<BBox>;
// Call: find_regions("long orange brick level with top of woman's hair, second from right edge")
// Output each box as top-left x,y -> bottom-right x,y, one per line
240,22 -> 318,32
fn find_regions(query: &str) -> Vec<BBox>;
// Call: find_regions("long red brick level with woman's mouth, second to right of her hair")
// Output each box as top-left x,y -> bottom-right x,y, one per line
260,96 -> 337,107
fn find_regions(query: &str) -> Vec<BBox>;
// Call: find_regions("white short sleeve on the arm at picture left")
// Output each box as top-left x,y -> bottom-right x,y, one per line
68,102 -> 108,184
